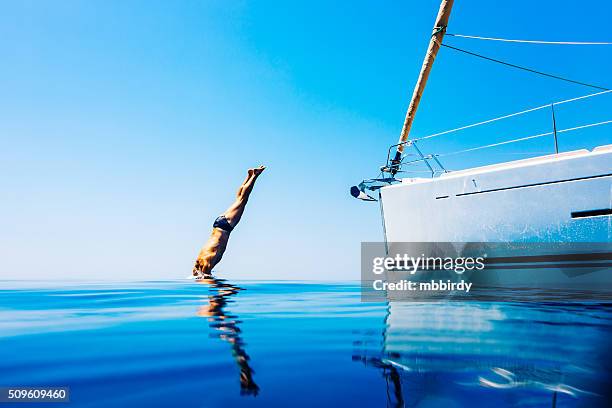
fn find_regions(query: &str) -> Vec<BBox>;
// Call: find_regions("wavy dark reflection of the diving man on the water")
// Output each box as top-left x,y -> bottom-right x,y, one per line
198,278 -> 259,395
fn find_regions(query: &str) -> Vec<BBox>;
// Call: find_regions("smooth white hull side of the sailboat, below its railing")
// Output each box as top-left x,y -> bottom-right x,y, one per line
380,145 -> 612,242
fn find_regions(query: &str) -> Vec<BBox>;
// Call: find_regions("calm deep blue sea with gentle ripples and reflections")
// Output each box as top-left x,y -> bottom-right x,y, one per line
0,281 -> 612,408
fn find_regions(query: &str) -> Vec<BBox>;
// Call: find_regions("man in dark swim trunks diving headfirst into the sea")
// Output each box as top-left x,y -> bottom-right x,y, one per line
193,166 -> 265,278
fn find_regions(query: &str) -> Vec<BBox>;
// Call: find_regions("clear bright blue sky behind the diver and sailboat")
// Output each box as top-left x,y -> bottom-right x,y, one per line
0,0 -> 612,280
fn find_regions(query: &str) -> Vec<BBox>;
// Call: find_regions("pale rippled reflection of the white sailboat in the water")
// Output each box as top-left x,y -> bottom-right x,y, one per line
353,292 -> 612,407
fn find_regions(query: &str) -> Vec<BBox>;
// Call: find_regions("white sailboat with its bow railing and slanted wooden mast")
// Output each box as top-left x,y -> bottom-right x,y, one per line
351,0 -> 612,250
